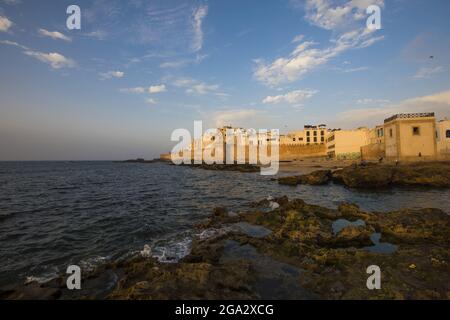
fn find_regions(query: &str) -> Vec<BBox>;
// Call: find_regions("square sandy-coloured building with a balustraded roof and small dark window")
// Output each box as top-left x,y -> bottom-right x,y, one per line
384,113 -> 437,161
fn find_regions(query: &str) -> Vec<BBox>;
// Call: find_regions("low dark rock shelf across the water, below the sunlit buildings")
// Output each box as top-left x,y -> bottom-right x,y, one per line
278,161 -> 450,188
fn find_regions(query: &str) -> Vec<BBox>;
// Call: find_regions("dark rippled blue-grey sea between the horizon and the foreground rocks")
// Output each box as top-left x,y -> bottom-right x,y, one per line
0,162 -> 450,287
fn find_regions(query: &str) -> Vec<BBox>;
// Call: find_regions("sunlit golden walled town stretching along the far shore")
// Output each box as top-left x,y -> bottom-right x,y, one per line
161,112 -> 450,162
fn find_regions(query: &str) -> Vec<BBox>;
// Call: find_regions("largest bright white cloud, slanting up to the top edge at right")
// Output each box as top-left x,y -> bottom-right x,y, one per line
254,0 -> 384,87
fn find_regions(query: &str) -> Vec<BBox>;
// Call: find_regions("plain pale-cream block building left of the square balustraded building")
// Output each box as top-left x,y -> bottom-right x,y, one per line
326,128 -> 369,160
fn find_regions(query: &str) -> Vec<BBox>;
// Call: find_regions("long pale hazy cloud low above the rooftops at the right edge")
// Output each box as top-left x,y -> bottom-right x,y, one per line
337,90 -> 450,126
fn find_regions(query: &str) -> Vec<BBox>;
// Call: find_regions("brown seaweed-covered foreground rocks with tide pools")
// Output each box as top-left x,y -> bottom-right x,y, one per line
0,195 -> 450,299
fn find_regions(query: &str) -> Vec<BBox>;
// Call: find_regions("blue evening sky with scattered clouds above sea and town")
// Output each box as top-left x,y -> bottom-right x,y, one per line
0,0 -> 450,160
